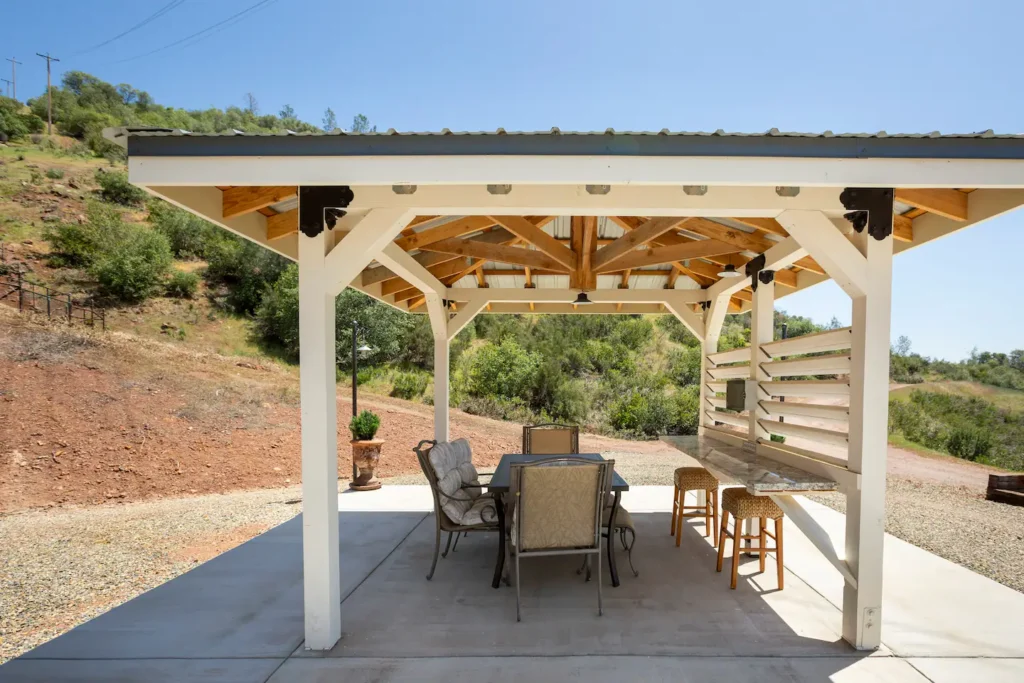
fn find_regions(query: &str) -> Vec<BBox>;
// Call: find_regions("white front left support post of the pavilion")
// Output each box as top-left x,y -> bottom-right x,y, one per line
298,223 -> 341,650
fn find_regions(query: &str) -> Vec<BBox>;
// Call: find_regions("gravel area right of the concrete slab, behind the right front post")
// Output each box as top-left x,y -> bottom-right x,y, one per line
808,475 -> 1024,592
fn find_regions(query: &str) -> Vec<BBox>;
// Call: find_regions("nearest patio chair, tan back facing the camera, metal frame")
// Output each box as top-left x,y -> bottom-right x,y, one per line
509,458 -> 615,622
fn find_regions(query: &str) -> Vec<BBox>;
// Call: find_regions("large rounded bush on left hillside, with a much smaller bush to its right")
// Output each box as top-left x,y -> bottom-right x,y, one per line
89,223 -> 173,303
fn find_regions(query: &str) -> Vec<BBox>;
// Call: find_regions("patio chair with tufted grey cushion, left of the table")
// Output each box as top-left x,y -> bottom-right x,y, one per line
413,438 -> 501,581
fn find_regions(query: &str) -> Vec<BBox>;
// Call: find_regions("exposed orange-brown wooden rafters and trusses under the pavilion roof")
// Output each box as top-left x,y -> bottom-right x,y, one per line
219,186 -> 971,310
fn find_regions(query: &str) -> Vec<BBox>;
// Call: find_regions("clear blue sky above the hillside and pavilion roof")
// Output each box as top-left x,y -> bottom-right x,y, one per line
8,0 -> 1024,358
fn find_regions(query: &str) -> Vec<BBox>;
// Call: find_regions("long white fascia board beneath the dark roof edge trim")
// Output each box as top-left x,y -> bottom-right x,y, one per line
128,155 -> 1024,187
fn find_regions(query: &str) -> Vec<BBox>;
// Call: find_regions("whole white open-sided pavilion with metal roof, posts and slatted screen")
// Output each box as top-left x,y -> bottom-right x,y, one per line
106,129 -> 1024,650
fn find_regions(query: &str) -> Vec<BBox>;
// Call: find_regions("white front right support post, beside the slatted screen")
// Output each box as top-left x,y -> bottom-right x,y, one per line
843,227 -> 893,650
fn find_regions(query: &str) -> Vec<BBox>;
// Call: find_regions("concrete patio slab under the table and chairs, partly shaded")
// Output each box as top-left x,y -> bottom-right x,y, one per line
8,486 -> 1024,683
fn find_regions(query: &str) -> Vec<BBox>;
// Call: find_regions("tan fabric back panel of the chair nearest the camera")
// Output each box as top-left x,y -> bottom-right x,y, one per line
513,465 -> 600,551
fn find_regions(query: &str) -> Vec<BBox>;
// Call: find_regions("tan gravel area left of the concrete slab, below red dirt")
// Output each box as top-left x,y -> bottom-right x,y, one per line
0,487 -> 301,664
